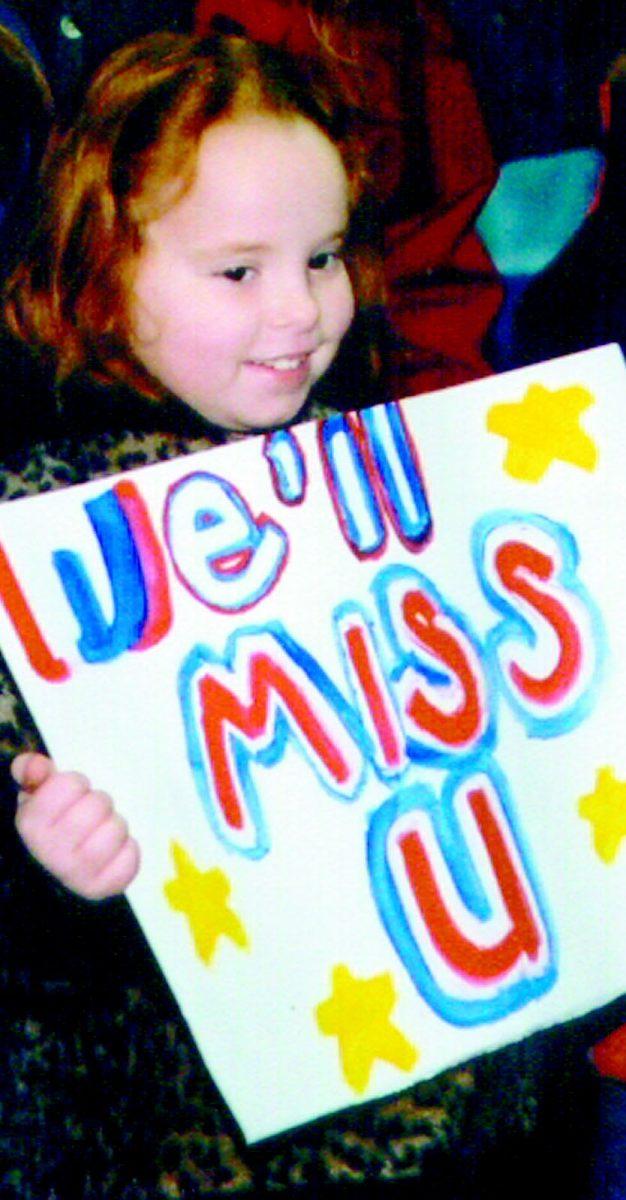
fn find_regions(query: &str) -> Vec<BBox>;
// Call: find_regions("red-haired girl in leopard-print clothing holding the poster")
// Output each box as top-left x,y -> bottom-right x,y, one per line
0,28 -> 604,1200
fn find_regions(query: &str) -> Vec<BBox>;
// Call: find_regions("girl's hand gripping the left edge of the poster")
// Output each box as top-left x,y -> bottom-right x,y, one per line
11,752 -> 139,900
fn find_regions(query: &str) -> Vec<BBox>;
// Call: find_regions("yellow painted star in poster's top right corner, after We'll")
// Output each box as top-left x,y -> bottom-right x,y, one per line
487,383 -> 597,484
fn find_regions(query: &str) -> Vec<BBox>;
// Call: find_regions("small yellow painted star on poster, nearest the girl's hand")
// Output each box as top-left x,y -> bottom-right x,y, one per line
163,841 -> 249,965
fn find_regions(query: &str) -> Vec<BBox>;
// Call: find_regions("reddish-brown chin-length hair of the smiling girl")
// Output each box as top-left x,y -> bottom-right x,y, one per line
5,32 -> 378,398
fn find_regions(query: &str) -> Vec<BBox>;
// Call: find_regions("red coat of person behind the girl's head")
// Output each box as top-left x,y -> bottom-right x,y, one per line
195,0 -> 501,397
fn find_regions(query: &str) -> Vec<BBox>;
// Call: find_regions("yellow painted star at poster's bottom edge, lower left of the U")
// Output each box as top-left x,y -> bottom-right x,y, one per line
315,965 -> 419,1093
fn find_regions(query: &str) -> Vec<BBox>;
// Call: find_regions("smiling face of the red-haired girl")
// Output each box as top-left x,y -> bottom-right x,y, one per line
131,114 -> 354,432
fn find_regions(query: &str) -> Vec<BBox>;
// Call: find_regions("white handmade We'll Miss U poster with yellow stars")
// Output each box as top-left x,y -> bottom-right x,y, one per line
0,347 -> 626,1140
